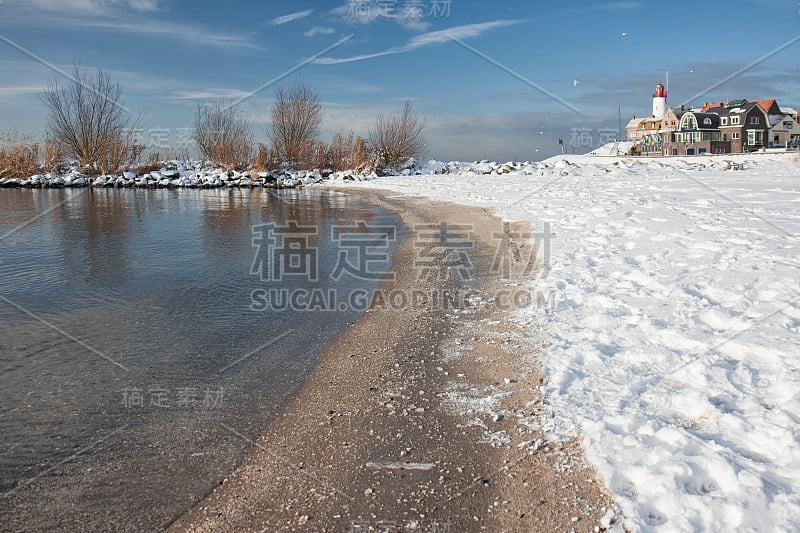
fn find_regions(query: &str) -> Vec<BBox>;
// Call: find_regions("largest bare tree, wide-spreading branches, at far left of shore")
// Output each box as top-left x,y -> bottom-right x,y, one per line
42,65 -> 144,172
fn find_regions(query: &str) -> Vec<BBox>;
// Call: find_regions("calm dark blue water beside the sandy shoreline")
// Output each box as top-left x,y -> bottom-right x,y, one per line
0,189 -> 402,530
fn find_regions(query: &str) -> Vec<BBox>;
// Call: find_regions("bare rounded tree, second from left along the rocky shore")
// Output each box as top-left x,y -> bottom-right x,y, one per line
194,100 -> 254,170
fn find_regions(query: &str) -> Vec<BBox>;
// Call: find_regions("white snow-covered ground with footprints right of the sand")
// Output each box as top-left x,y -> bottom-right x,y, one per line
324,154 -> 800,531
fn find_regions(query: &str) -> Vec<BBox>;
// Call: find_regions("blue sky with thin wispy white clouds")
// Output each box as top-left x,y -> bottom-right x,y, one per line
0,0 -> 800,161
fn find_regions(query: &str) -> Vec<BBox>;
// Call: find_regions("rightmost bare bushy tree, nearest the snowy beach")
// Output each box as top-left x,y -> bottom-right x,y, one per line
369,100 -> 428,170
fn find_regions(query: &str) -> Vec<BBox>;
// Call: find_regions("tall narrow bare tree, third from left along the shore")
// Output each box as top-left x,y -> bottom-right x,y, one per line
268,82 -> 323,166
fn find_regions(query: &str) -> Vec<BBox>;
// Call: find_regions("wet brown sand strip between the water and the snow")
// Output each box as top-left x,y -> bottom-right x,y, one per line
171,190 -> 613,532
